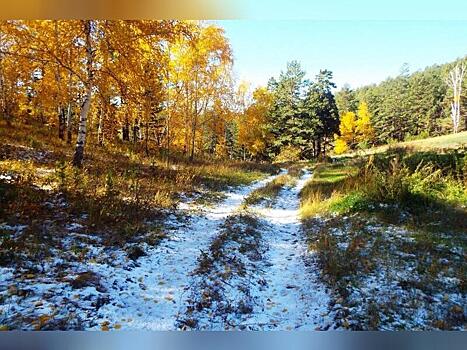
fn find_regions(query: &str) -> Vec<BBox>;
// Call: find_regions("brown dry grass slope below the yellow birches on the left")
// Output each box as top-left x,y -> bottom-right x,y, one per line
0,121 -> 279,264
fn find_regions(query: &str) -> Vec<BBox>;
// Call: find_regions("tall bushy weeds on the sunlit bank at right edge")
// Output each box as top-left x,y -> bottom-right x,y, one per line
354,150 -> 467,206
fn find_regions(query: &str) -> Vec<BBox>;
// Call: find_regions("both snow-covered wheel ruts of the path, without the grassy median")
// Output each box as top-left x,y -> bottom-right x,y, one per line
95,172 -> 330,330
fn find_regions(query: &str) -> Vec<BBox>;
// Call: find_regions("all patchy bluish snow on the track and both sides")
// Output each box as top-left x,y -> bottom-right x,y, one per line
0,165 -> 467,330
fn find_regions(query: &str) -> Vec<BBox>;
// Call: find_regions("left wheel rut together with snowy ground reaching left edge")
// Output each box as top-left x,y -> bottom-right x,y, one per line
0,176 -> 274,330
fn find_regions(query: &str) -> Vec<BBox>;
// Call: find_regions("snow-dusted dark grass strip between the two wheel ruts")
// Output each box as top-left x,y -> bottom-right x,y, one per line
178,210 -> 264,329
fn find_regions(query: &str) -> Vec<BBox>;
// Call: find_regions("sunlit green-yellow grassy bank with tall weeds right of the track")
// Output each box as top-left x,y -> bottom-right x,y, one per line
301,149 -> 467,228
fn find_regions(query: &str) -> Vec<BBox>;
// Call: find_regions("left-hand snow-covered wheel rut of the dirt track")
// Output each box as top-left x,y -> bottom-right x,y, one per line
93,171 -> 277,330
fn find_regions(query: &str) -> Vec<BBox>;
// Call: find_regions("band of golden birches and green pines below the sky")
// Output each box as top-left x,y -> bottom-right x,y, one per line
1,21 -> 466,166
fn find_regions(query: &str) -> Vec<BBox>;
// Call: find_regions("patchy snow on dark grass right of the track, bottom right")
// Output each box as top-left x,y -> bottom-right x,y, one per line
320,219 -> 467,330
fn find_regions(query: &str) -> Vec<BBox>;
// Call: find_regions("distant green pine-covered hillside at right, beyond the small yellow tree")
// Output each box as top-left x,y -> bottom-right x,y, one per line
335,57 -> 467,144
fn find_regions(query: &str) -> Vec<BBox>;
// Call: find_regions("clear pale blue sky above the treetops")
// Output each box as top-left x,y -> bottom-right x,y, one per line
216,19 -> 467,88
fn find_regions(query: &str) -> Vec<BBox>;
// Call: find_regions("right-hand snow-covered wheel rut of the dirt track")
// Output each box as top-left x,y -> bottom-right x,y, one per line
250,172 -> 332,330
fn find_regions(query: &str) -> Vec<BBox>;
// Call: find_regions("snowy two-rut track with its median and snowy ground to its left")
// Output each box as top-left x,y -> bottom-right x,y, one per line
0,170 -> 330,330
